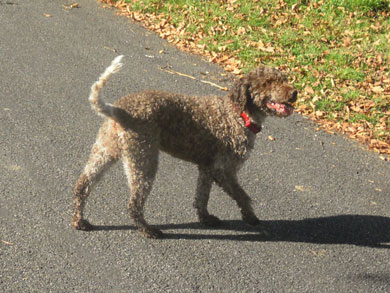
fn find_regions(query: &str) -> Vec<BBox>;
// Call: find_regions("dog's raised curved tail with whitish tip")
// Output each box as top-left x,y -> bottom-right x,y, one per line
88,55 -> 123,118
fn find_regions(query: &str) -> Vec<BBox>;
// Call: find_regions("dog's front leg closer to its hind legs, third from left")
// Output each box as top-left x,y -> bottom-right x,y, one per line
194,167 -> 221,226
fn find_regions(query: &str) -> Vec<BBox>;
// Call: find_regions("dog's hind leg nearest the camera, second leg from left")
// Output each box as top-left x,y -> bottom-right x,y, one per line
122,134 -> 162,238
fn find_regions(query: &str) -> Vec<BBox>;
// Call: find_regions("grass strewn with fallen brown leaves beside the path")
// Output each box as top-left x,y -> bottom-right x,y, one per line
102,0 -> 390,154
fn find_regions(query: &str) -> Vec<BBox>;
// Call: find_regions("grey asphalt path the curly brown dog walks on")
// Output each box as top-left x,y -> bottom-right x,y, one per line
0,0 -> 390,292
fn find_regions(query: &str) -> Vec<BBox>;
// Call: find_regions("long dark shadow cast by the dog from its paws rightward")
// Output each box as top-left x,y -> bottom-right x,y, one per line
94,215 -> 390,248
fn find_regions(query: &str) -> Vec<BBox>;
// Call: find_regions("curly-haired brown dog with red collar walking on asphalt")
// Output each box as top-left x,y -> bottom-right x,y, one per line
72,56 -> 297,238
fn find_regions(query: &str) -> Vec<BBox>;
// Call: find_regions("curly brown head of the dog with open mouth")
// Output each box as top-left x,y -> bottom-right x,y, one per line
229,66 -> 298,119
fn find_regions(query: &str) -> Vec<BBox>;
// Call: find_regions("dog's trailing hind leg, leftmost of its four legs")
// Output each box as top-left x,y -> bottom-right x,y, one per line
72,139 -> 116,231
